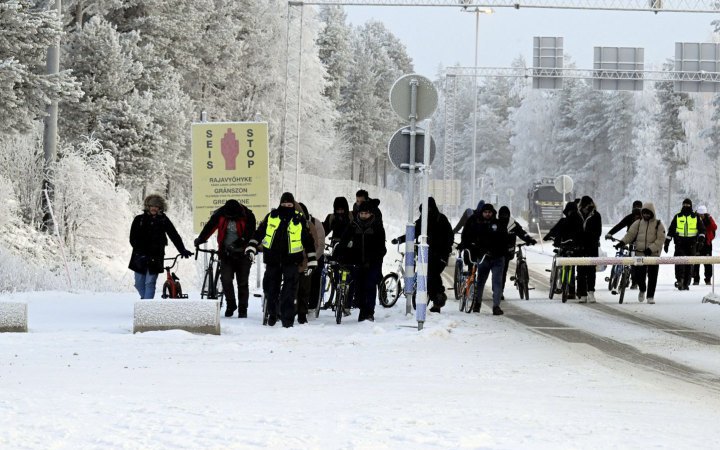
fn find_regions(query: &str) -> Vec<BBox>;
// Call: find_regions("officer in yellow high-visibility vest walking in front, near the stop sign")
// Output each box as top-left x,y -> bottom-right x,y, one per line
245,192 -> 317,328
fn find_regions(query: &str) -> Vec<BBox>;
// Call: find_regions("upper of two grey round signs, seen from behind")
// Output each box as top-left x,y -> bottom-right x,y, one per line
390,73 -> 438,122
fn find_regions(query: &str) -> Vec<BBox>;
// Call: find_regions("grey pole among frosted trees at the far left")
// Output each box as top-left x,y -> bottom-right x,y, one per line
42,0 -> 62,231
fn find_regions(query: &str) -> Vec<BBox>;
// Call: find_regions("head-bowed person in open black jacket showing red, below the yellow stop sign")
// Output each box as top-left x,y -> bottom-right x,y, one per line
194,199 -> 256,318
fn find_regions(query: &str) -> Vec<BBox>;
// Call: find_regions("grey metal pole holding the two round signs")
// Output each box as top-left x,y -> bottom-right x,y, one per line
405,78 -> 419,314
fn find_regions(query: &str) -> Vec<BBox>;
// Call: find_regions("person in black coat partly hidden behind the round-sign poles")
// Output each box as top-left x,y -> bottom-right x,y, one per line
392,197 -> 453,313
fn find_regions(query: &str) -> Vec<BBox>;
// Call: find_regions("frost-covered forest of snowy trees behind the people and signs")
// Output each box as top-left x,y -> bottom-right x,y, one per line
0,0 -> 720,291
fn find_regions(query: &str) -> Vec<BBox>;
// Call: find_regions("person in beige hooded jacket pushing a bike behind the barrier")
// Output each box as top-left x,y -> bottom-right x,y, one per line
615,202 -> 665,304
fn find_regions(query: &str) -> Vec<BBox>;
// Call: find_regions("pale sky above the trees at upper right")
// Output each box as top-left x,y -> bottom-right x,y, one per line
345,6 -> 720,78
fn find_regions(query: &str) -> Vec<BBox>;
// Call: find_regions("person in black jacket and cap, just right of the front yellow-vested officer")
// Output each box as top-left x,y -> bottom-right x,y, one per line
334,202 -> 387,322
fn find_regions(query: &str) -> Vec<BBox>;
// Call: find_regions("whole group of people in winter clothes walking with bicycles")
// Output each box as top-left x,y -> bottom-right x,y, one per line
129,189 -> 717,327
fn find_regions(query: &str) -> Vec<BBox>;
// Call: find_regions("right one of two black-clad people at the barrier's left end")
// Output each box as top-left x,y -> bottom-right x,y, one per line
575,195 -> 602,303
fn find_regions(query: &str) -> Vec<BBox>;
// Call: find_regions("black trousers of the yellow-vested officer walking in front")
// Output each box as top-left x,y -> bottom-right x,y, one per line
263,264 -> 299,327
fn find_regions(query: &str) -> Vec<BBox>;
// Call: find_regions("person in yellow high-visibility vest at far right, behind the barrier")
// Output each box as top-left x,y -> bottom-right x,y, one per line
663,198 -> 705,291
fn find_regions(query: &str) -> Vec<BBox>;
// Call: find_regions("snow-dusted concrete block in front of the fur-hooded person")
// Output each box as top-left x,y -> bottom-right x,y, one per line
133,299 -> 220,335
